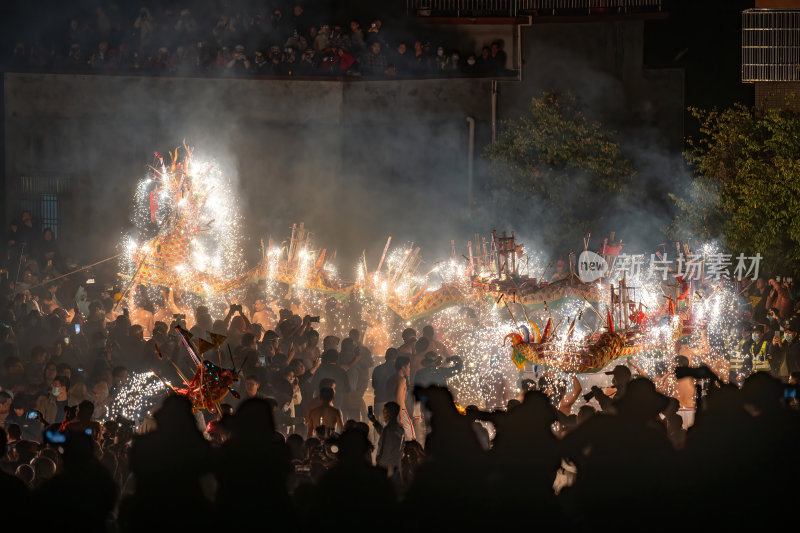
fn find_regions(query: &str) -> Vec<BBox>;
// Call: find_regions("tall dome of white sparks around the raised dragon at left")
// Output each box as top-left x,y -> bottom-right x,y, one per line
122,150 -> 244,316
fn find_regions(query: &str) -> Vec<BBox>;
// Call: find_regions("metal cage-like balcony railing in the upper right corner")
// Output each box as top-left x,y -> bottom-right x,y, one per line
742,9 -> 800,82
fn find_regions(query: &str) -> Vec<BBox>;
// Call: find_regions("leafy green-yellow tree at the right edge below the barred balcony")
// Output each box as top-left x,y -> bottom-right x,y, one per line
672,105 -> 800,273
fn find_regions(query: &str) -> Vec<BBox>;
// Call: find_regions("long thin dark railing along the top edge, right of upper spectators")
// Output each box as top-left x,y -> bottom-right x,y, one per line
406,0 -> 662,17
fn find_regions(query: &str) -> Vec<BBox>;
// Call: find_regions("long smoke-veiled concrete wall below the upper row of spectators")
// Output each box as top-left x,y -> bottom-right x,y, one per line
5,74 -> 490,262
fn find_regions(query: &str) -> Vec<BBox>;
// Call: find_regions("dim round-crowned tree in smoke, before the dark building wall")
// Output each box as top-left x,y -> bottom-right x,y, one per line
484,92 -> 634,254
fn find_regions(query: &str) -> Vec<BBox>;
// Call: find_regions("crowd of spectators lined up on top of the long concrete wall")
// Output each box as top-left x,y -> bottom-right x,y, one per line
4,5 -> 507,78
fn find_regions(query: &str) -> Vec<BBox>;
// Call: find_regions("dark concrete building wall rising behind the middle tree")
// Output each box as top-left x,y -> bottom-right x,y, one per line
500,19 -> 684,145
